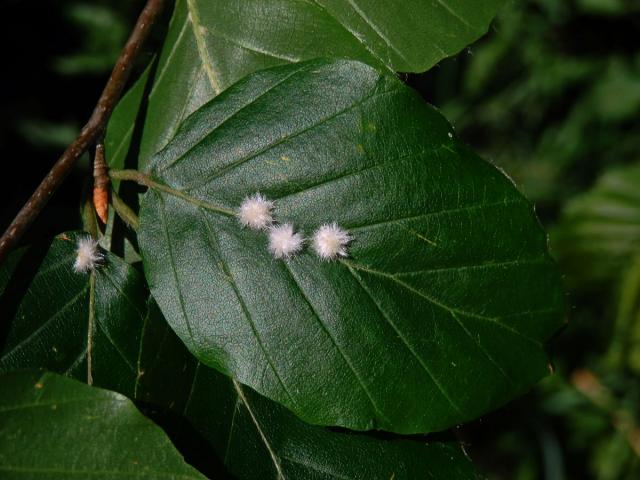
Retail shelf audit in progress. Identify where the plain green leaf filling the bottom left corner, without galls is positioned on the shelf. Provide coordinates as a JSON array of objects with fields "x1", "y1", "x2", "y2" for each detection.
[{"x1": 0, "y1": 372, "x2": 205, "y2": 480}]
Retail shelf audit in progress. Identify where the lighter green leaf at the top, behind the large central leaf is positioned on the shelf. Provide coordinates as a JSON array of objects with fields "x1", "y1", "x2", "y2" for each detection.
[{"x1": 132, "y1": 0, "x2": 503, "y2": 165}]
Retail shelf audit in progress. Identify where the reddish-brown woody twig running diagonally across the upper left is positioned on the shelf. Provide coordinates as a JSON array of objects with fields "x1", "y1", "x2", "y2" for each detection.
[{"x1": 0, "y1": 0, "x2": 164, "y2": 263}]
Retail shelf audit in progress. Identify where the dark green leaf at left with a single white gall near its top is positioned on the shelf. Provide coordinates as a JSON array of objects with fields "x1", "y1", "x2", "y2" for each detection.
[{"x1": 0, "y1": 233, "x2": 148, "y2": 397}]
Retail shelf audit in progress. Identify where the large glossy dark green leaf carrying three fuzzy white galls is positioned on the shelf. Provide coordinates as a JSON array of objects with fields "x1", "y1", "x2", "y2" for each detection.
[{"x1": 138, "y1": 61, "x2": 564, "y2": 433}]
